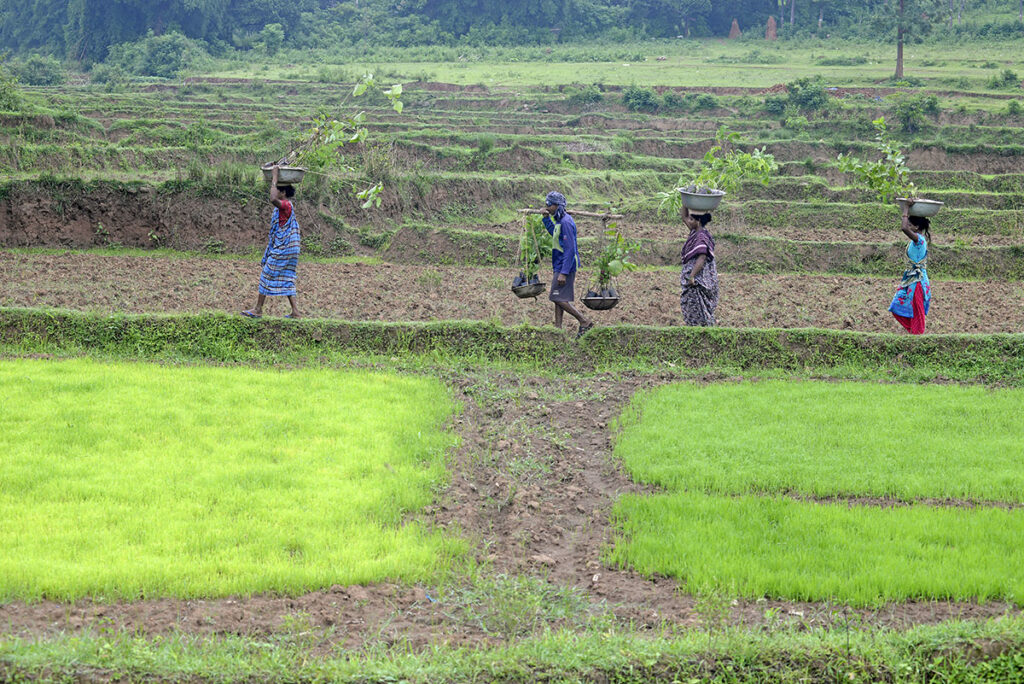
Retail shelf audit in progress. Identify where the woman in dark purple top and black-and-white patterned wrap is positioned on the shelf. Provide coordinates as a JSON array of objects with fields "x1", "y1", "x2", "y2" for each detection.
[{"x1": 679, "y1": 207, "x2": 718, "y2": 326}]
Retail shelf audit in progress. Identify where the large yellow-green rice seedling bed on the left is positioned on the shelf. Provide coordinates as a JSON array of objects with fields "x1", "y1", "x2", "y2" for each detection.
[{"x1": 0, "y1": 360, "x2": 462, "y2": 601}]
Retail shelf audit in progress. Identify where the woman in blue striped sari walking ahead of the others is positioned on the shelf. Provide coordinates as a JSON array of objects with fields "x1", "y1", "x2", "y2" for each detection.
[{"x1": 242, "y1": 166, "x2": 300, "y2": 318}]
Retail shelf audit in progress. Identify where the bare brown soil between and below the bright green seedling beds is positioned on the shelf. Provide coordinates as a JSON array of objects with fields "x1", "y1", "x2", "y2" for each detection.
[{"x1": 0, "y1": 374, "x2": 1016, "y2": 648}]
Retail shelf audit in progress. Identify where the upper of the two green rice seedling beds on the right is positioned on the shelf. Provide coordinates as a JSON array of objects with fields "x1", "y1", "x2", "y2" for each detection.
[{"x1": 615, "y1": 381, "x2": 1024, "y2": 503}]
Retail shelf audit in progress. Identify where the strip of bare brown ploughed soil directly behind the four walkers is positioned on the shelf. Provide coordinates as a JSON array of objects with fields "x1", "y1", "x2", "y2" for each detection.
[{"x1": 0, "y1": 251, "x2": 1024, "y2": 333}]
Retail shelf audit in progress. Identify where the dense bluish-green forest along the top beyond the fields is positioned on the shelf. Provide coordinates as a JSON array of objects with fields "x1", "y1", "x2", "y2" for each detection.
[{"x1": 0, "y1": 0, "x2": 1024, "y2": 63}]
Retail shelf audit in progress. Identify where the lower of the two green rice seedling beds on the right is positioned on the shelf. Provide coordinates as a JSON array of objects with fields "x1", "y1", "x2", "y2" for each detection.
[{"x1": 608, "y1": 491, "x2": 1024, "y2": 606}]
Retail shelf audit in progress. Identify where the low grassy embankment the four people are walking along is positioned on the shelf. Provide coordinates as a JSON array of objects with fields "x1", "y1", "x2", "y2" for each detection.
[{"x1": 0, "y1": 308, "x2": 1024, "y2": 386}]
